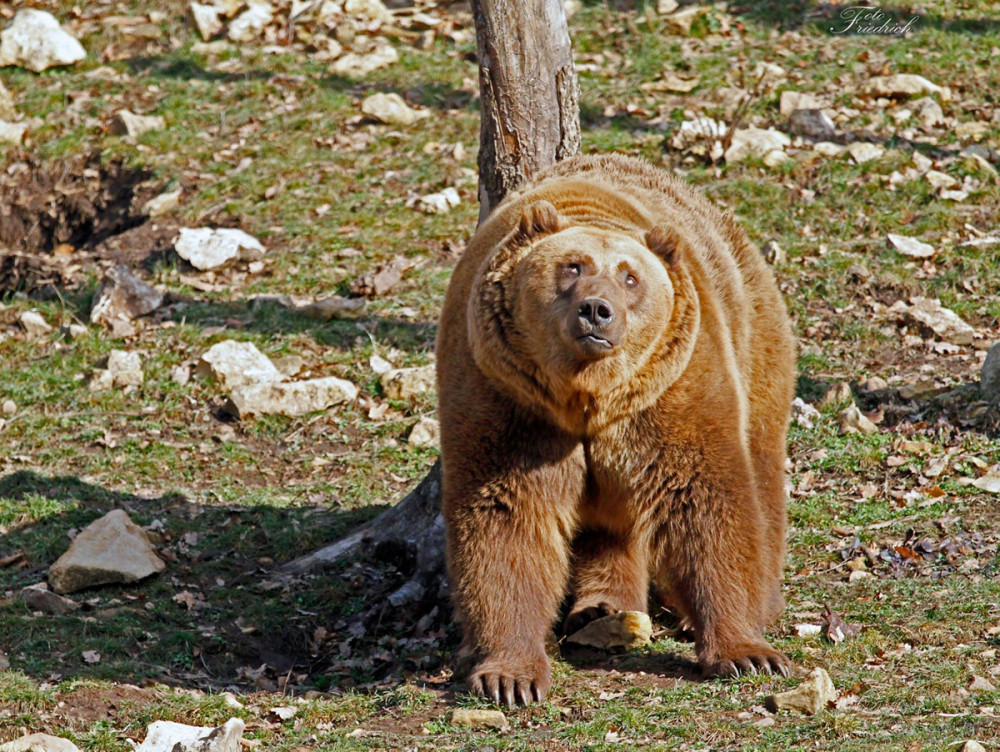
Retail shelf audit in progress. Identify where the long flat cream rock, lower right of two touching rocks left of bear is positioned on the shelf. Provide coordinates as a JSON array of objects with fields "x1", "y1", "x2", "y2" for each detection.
[{"x1": 226, "y1": 376, "x2": 358, "y2": 418}]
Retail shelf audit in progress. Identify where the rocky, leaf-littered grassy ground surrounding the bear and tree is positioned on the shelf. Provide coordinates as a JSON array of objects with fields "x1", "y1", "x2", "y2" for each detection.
[{"x1": 0, "y1": 0, "x2": 1000, "y2": 752}]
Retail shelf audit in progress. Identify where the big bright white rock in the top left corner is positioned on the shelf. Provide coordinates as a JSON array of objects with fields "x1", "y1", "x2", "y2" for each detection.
[{"x1": 0, "y1": 8, "x2": 87, "y2": 73}]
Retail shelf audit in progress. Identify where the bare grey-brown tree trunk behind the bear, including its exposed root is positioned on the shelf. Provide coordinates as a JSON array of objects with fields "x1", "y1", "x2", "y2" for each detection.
[{"x1": 282, "y1": 0, "x2": 580, "y2": 608}]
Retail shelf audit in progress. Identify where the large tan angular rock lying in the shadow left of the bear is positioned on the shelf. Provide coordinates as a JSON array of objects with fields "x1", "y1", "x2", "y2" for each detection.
[{"x1": 49, "y1": 509, "x2": 166, "y2": 594}]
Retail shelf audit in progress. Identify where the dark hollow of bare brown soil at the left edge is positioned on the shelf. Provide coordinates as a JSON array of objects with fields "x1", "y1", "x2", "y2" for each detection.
[{"x1": 0, "y1": 152, "x2": 164, "y2": 293}]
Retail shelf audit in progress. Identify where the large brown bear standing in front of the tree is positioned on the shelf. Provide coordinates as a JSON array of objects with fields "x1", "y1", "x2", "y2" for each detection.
[{"x1": 437, "y1": 155, "x2": 794, "y2": 705}]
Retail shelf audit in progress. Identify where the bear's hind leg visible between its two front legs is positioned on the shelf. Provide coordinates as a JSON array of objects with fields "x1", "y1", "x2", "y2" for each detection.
[{"x1": 563, "y1": 529, "x2": 649, "y2": 635}]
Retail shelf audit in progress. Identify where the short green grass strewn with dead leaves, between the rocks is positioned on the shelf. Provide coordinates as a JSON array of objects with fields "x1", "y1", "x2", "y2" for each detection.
[{"x1": 0, "y1": 0, "x2": 1000, "y2": 752}]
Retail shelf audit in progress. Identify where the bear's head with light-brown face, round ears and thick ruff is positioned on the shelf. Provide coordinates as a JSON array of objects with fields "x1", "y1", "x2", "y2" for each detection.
[{"x1": 470, "y1": 201, "x2": 697, "y2": 434}]
